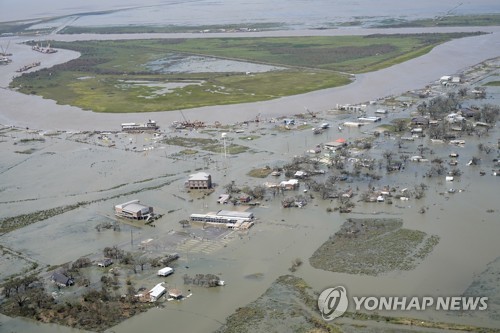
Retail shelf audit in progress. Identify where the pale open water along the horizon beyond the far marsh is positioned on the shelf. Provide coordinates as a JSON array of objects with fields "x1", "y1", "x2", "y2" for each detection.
[{"x1": 0, "y1": 0, "x2": 499, "y2": 29}]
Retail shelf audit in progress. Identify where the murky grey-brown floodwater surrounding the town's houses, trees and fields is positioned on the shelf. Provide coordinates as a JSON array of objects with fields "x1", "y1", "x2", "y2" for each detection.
[{"x1": 0, "y1": 85, "x2": 500, "y2": 333}]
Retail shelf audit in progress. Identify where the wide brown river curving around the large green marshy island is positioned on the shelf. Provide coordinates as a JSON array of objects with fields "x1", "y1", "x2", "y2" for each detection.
[{"x1": 0, "y1": 27, "x2": 500, "y2": 131}]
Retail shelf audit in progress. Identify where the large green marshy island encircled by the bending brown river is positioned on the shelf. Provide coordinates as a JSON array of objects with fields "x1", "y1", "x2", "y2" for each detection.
[{"x1": 11, "y1": 33, "x2": 480, "y2": 113}]
